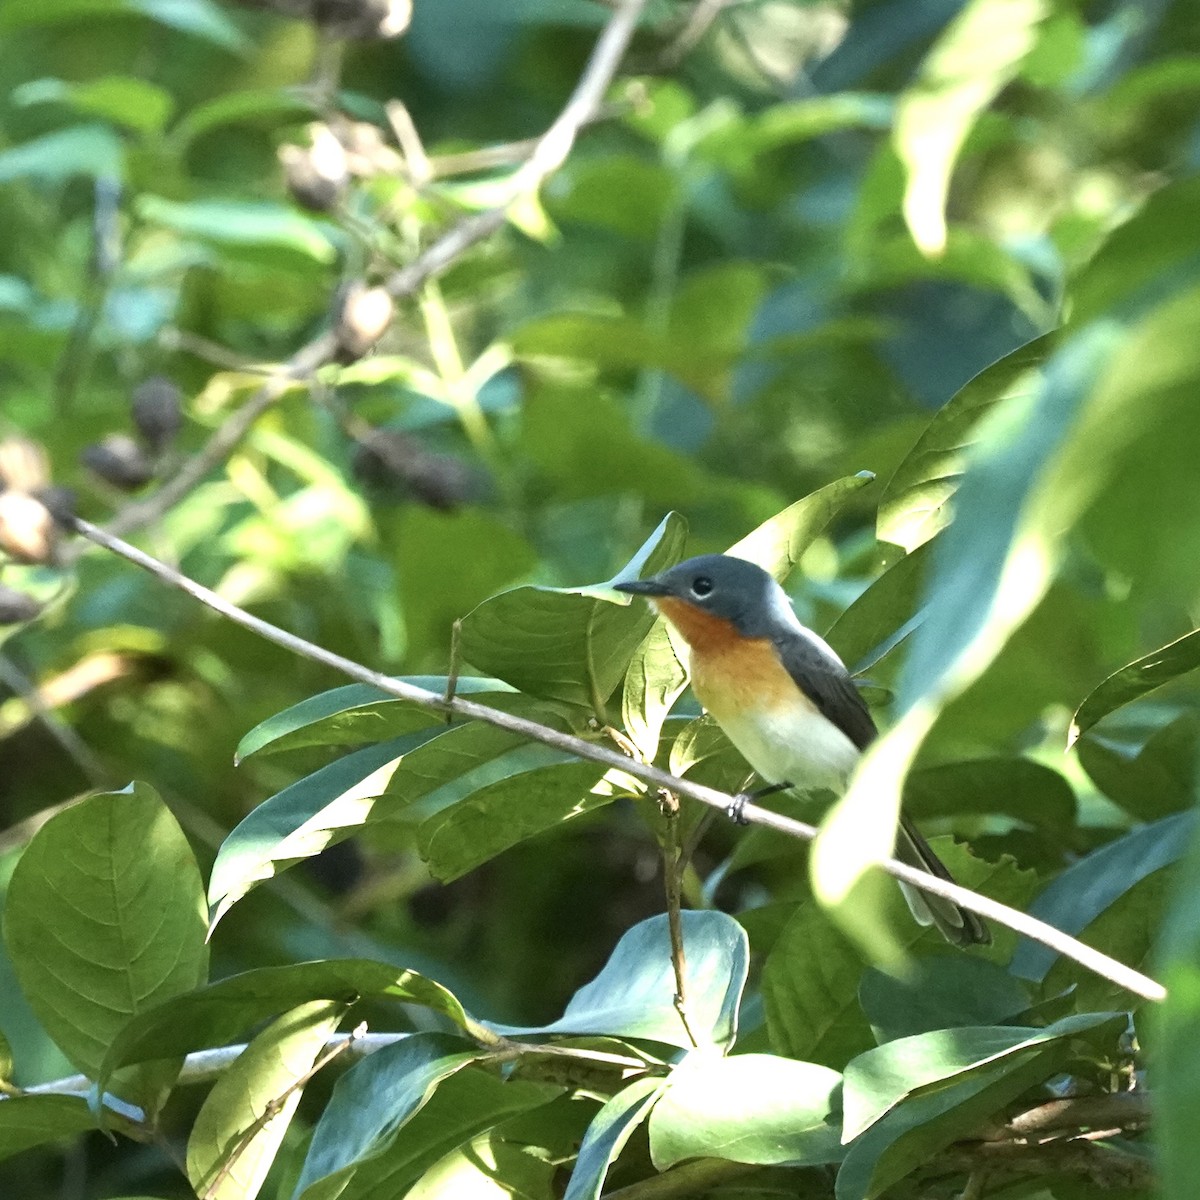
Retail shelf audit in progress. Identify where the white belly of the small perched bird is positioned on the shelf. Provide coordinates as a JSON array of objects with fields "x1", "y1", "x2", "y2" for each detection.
[{"x1": 713, "y1": 706, "x2": 858, "y2": 792}]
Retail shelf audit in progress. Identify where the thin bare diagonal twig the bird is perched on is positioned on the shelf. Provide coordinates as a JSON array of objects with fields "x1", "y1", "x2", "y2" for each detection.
[{"x1": 66, "y1": 517, "x2": 1166, "y2": 1001}]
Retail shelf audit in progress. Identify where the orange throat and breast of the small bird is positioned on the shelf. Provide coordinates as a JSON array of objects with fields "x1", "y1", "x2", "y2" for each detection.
[{"x1": 656, "y1": 596, "x2": 814, "y2": 722}]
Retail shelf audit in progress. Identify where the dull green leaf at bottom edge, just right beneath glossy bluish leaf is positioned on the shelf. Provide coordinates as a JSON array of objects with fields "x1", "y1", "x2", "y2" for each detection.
[{"x1": 326, "y1": 1067, "x2": 563, "y2": 1200}]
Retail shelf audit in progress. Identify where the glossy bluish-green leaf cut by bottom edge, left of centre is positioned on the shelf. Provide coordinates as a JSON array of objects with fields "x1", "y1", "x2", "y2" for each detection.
[{"x1": 292, "y1": 1033, "x2": 484, "y2": 1200}]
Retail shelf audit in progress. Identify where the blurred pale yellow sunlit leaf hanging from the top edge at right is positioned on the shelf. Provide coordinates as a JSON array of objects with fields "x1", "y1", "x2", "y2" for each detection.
[{"x1": 893, "y1": 0, "x2": 1050, "y2": 254}]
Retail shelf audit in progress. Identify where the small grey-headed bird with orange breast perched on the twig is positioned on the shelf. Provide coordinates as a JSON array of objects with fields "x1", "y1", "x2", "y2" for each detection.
[{"x1": 616, "y1": 554, "x2": 991, "y2": 946}]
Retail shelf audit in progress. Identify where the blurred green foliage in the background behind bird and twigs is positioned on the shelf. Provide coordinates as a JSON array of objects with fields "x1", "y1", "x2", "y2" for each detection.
[{"x1": 0, "y1": 0, "x2": 1200, "y2": 1196}]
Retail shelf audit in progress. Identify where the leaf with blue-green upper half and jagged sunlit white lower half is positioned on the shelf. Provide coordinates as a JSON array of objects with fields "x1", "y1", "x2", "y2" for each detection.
[{"x1": 209, "y1": 726, "x2": 444, "y2": 931}]
